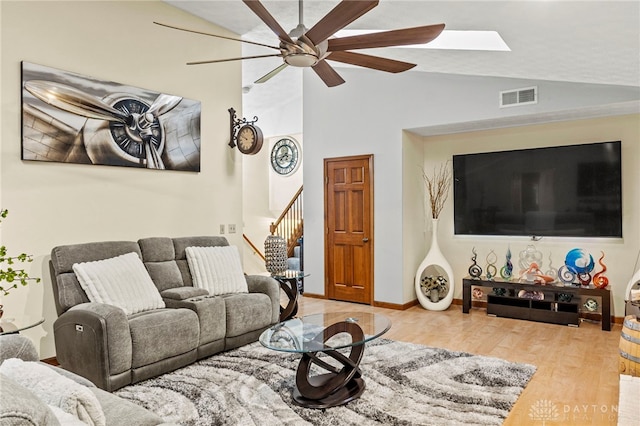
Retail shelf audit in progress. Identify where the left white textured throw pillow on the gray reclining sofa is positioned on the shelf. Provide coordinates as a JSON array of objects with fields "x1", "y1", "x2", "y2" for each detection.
[{"x1": 73, "y1": 252, "x2": 165, "y2": 315}]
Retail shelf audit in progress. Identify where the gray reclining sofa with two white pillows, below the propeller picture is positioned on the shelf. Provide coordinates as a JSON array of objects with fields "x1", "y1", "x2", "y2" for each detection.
[{"x1": 50, "y1": 236, "x2": 280, "y2": 391}]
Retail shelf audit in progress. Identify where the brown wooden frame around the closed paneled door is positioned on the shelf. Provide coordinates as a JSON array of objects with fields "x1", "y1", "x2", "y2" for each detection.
[{"x1": 322, "y1": 154, "x2": 375, "y2": 306}]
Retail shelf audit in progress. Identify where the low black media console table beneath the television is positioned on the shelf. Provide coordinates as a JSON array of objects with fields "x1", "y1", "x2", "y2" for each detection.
[{"x1": 462, "y1": 278, "x2": 611, "y2": 331}]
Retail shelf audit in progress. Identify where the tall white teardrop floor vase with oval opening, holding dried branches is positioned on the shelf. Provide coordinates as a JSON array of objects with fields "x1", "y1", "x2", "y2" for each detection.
[{"x1": 415, "y1": 219, "x2": 455, "y2": 311}]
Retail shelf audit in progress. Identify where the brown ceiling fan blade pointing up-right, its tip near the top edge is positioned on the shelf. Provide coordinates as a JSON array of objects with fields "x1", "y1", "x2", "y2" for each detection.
[{"x1": 305, "y1": 0, "x2": 378, "y2": 45}]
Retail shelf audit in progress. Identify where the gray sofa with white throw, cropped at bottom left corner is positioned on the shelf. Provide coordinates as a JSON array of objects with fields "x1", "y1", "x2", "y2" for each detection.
[{"x1": 0, "y1": 334, "x2": 169, "y2": 426}]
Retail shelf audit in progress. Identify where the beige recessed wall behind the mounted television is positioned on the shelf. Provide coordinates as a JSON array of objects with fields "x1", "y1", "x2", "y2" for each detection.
[{"x1": 404, "y1": 114, "x2": 640, "y2": 317}]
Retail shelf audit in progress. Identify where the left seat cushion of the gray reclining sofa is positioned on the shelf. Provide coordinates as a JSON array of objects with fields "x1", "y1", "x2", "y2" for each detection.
[{"x1": 129, "y1": 309, "x2": 200, "y2": 368}]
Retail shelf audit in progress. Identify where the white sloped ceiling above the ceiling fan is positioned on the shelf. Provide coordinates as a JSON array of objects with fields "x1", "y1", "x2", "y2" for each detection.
[{"x1": 165, "y1": 0, "x2": 640, "y2": 87}]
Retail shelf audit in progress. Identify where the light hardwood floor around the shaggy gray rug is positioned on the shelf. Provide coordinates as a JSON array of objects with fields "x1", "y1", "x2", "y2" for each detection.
[{"x1": 298, "y1": 296, "x2": 624, "y2": 426}]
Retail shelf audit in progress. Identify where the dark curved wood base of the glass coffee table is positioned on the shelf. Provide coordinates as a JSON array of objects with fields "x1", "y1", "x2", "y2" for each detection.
[{"x1": 293, "y1": 321, "x2": 365, "y2": 408}]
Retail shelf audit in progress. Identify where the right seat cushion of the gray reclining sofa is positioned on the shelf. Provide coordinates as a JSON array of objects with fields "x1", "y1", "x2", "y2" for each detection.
[{"x1": 223, "y1": 293, "x2": 272, "y2": 337}]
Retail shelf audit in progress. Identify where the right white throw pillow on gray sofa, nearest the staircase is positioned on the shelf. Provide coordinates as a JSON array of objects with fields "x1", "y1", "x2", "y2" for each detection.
[{"x1": 185, "y1": 246, "x2": 249, "y2": 296}]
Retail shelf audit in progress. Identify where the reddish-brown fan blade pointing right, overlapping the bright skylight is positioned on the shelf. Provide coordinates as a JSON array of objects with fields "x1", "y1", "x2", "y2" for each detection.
[{"x1": 327, "y1": 24, "x2": 444, "y2": 52}]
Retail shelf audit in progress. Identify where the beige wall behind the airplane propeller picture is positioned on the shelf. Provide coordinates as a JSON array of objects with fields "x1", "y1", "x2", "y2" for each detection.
[{"x1": 0, "y1": 1, "x2": 242, "y2": 358}]
